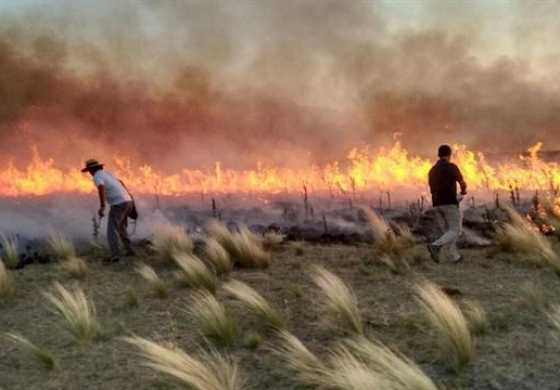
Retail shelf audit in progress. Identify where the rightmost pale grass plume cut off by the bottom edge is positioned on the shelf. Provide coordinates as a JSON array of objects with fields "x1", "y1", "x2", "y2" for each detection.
[{"x1": 346, "y1": 337, "x2": 437, "y2": 390}]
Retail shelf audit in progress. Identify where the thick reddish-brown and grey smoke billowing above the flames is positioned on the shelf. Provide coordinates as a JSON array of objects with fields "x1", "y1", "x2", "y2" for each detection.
[{"x1": 0, "y1": 0, "x2": 560, "y2": 171}]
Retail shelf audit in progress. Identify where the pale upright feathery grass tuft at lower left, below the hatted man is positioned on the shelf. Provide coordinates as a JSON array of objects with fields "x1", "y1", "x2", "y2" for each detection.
[{"x1": 43, "y1": 282, "x2": 101, "y2": 342}]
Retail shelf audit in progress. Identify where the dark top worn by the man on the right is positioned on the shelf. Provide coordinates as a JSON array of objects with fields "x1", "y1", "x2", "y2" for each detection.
[{"x1": 429, "y1": 160, "x2": 467, "y2": 207}]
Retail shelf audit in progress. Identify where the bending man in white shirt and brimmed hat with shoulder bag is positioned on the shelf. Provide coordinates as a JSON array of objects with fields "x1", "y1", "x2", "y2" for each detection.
[{"x1": 82, "y1": 159, "x2": 134, "y2": 263}]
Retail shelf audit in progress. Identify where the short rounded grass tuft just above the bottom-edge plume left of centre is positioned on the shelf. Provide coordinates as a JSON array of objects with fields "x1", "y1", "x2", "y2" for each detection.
[{"x1": 189, "y1": 291, "x2": 237, "y2": 346}]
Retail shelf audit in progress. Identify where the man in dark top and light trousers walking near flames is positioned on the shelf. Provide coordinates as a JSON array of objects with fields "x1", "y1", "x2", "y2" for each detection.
[{"x1": 428, "y1": 145, "x2": 467, "y2": 263}]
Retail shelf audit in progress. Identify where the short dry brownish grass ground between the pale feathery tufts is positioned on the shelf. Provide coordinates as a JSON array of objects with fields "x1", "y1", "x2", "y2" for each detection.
[{"x1": 0, "y1": 243, "x2": 560, "y2": 390}]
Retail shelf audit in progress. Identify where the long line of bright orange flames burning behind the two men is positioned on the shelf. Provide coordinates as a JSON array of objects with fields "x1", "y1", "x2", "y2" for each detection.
[{"x1": 0, "y1": 142, "x2": 560, "y2": 197}]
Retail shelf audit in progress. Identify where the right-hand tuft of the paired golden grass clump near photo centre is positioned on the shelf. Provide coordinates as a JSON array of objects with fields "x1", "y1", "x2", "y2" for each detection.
[{"x1": 233, "y1": 226, "x2": 270, "y2": 268}]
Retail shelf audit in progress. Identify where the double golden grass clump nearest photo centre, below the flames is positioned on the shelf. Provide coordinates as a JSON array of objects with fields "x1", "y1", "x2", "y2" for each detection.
[{"x1": 206, "y1": 221, "x2": 270, "y2": 268}]
